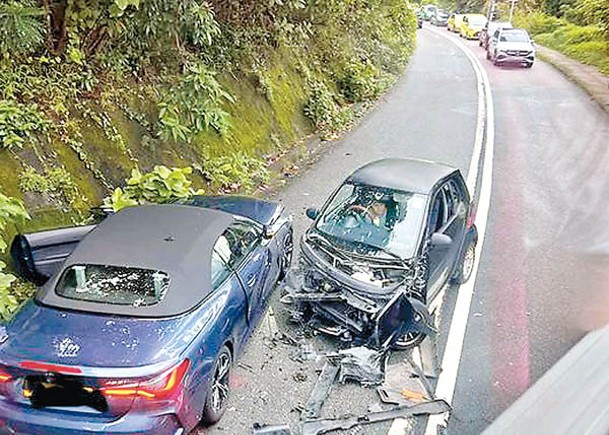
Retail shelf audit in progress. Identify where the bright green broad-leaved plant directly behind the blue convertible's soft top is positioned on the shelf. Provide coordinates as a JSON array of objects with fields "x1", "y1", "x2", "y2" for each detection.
[{"x1": 104, "y1": 166, "x2": 203, "y2": 212}]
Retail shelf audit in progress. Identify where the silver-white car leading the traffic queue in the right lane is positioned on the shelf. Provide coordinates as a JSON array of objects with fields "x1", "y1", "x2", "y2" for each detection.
[{"x1": 486, "y1": 29, "x2": 535, "y2": 68}]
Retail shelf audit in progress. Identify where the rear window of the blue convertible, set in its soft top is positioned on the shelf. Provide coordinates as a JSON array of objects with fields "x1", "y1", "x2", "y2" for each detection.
[{"x1": 55, "y1": 264, "x2": 169, "y2": 307}]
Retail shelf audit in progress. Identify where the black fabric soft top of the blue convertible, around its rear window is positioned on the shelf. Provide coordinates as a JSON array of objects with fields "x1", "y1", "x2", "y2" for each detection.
[{"x1": 37, "y1": 204, "x2": 235, "y2": 317}]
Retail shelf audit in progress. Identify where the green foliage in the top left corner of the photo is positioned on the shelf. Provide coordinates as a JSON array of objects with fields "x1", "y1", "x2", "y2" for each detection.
[{"x1": 0, "y1": 0, "x2": 44, "y2": 54}]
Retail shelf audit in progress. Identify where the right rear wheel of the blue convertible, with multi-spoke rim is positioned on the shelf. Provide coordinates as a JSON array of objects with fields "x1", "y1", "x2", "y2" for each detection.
[{"x1": 201, "y1": 346, "x2": 233, "y2": 426}]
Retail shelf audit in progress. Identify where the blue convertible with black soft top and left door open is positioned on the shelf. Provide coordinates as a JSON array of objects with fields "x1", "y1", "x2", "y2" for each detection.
[{"x1": 0, "y1": 196, "x2": 292, "y2": 435}]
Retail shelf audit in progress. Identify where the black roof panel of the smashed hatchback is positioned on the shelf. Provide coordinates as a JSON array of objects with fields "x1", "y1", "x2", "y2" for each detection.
[{"x1": 346, "y1": 158, "x2": 459, "y2": 195}]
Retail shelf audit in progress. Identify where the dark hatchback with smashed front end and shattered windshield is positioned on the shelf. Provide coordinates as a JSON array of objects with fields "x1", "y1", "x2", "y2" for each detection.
[{"x1": 282, "y1": 159, "x2": 477, "y2": 349}]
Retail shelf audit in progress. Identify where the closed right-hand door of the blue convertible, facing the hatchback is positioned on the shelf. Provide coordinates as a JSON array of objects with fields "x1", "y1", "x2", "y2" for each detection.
[{"x1": 226, "y1": 222, "x2": 274, "y2": 326}]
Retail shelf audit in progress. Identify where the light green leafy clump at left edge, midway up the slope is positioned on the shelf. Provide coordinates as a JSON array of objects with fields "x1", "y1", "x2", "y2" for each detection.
[{"x1": 0, "y1": 100, "x2": 50, "y2": 149}]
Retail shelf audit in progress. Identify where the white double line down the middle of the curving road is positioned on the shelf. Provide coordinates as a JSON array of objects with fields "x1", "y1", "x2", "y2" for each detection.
[{"x1": 425, "y1": 26, "x2": 495, "y2": 435}]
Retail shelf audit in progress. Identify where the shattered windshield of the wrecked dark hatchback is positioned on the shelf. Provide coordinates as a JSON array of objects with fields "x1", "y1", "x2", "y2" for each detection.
[{"x1": 315, "y1": 184, "x2": 427, "y2": 259}]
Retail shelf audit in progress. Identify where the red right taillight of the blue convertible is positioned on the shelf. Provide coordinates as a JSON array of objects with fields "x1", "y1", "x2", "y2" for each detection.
[{"x1": 100, "y1": 359, "x2": 190, "y2": 399}]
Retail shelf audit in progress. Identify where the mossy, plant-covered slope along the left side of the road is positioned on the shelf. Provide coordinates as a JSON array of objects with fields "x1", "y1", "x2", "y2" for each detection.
[{"x1": 0, "y1": 0, "x2": 416, "y2": 316}]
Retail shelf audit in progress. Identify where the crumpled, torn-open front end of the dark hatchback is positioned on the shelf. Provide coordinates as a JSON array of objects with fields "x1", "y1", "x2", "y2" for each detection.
[{"x1": 282, "y1": 233, "x2": 432, "y2": 348}]
